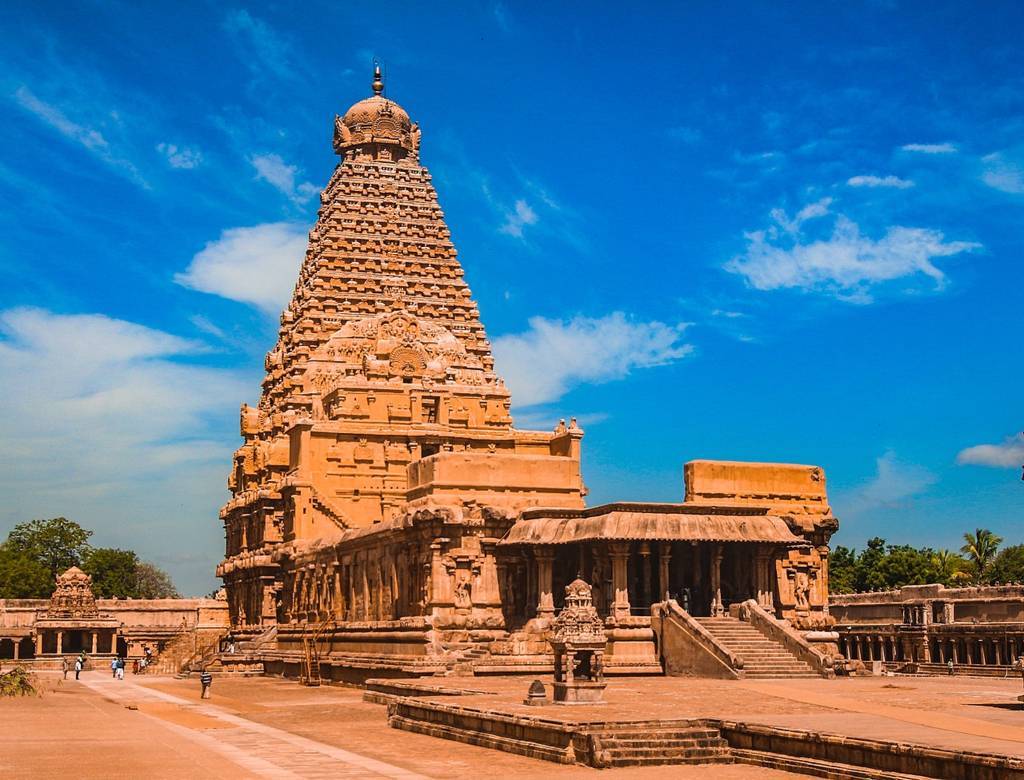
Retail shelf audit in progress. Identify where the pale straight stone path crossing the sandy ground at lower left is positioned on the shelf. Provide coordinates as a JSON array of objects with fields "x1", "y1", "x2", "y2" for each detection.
[{"x1": 83, "y1": 676, "x2": 426, "y2": 780}]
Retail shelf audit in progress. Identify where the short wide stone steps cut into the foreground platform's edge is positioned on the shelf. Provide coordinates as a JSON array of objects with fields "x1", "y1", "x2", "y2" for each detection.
[{"x1": 591, "y1": 726, "x2": 732, "y2": 767}]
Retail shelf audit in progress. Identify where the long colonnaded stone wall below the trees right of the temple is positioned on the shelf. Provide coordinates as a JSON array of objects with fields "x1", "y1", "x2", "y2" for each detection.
[{"x1": 831, "y1": 584, "x2": 1024, "y2": 671}]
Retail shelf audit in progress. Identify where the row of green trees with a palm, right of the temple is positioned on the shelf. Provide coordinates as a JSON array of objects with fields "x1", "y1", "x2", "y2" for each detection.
[{"x1": 828, "y1": 528, "x2": 1024, "y2": 593}]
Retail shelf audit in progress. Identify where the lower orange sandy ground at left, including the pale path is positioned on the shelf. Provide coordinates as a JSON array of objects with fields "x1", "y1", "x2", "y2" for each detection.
[{"x1": 0, "y1": 671, "x2": 796, "y2": 780}]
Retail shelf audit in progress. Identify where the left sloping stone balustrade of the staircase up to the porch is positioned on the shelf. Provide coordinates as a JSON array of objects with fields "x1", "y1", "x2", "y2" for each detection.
[{"x1": 650, "y1": 599, "x2": 743, "y2": 679}]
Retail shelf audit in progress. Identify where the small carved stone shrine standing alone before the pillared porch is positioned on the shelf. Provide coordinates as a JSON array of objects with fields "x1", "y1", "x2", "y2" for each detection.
[{"x1": 551, "y1": 578, "x2": 607, "y2": 704}]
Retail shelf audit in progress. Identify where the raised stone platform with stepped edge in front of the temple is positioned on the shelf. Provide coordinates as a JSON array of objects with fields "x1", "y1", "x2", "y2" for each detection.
[{"x1": 366, "y1": 678, "x2": 1024, "y2": 780}]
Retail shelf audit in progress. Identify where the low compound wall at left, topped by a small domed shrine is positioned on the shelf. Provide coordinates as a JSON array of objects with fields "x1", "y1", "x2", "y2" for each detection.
[{"x1": 0, "y1": 567, "x2": 228, "y2": 662}]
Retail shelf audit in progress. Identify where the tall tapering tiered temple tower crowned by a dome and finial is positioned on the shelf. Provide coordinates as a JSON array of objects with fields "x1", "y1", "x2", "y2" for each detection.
[{"x1": 218, "y1": 69, "x2": 582, "y2": 627}]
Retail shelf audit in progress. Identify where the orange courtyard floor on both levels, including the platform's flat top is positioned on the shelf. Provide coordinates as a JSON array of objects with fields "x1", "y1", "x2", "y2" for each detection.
[{"x1": 6, "y1": 671, "x2": 1024, "y2": 780}]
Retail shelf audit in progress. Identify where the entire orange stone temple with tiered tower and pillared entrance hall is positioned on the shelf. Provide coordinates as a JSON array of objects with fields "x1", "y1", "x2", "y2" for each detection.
[{"x1": 217, "y1": 72, "x2": 838, "y2": 679}]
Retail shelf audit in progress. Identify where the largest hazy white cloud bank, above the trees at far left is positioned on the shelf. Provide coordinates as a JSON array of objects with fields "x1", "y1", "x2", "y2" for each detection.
[{"x1": 0, "y1": 308, "x2": 246, "y2": 593}]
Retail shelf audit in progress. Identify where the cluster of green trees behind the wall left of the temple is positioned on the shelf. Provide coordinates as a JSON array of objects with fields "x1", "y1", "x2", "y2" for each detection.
[{"x1": 0, "y1": 517, "x2": 178, "y2": 599}]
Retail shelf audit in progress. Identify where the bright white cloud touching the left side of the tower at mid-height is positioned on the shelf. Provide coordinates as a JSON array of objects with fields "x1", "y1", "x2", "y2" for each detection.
[{"x1": 174, "y1": 222, "x2": 307, "y2": 313}]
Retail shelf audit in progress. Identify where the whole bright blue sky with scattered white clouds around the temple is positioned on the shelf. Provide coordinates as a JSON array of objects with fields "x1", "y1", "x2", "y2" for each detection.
[{"x1": 0, "y1": 2, "x2": 1024, "y2": 593}]
